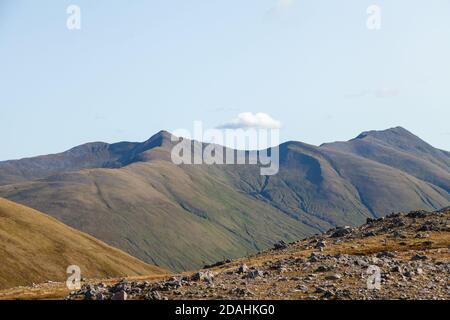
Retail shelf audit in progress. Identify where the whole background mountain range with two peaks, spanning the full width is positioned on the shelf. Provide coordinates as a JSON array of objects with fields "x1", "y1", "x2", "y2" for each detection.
[{"x1": 0, "y1": 128, "x2": 450, "y2": 271}]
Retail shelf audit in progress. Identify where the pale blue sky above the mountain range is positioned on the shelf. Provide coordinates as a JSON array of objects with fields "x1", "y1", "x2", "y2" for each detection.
[{"x1": 0, "y1": 0, "x2": 450, "y2": 160}]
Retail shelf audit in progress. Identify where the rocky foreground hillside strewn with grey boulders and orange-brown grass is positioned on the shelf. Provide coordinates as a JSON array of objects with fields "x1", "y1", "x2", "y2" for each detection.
[{"x1": 67, "y1": 208, "x2": 450, "y2": 300}]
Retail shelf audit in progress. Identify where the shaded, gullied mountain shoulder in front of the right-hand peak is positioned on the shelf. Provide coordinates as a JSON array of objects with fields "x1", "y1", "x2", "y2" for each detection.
[{"x1": 225, "y1": 142, "x2": 450, "y2": 225}]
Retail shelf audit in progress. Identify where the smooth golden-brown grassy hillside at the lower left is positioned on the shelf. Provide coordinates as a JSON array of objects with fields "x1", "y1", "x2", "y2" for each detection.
[{"x1": 0, "y1": 199, "x2": 166, "y2": 289}]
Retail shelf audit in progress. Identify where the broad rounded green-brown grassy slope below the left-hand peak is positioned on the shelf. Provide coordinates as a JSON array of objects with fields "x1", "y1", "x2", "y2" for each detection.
[{"x1": 1, "y1": 160, "x2": 316, "y2": 270}]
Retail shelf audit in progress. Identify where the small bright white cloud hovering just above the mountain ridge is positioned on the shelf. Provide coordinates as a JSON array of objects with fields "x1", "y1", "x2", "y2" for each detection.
[{"x1": 218, "y1": 112, "x2": 281, "y2": 129}]
